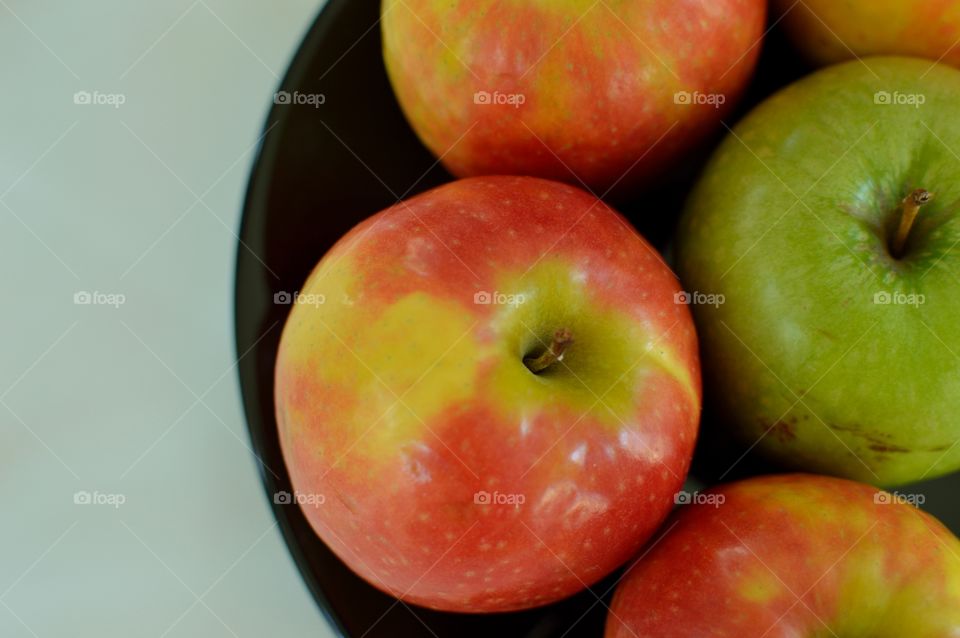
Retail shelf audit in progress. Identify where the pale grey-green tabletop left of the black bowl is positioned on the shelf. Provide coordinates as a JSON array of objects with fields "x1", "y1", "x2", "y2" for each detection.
[{"x1": 0, "y1": 0, "x2": 338, "y2": 638}]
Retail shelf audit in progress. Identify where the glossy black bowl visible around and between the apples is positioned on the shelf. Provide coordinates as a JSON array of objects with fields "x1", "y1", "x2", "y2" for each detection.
[{"x1": 236, "y1": 0, "x2": 960, "y2": 638}]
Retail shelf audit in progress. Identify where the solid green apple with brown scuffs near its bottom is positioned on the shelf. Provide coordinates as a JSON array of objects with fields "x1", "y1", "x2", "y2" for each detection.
[{"x1": 677, "y1": 57, "x2": 960, "y2": 485}]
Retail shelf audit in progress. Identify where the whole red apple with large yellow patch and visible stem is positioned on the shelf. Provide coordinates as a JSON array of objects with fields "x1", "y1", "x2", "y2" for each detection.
[{"x1": 276, "y1": 177, "x2": 700, "y2": 612}]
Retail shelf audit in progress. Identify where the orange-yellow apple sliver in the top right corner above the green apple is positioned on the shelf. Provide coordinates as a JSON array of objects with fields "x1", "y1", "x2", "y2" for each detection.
[{"x1": 771, "y1": 0, "x2": 960, "y2": 66}]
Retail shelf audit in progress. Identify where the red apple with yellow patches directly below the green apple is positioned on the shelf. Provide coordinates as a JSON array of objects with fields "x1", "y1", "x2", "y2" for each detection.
[{"x1": 605, "y1": 474, "x2": 960, "y2": 638}]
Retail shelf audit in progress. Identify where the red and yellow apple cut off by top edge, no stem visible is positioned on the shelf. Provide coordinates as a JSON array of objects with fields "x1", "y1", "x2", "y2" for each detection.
[{"x1": 382, "y1": 0, "x2": 766, "y2": 195}]
